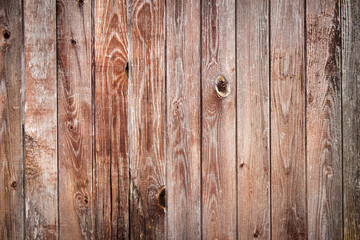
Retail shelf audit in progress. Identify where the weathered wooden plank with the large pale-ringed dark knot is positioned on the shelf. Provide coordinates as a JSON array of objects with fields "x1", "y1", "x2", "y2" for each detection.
[{"x1": 201, "y1": 0, "x2": 237, "y2": 239}]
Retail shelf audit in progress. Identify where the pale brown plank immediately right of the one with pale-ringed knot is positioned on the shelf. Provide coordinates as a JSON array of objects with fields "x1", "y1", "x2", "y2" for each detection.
[{"x1": 236, "y1": 0, "x2": 270, "y2": 239}]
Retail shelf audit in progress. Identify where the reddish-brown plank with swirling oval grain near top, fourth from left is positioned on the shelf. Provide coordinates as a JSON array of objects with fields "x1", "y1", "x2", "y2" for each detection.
[{"x1": 94, "y1": 0, "x2": 129, "y2": 239}]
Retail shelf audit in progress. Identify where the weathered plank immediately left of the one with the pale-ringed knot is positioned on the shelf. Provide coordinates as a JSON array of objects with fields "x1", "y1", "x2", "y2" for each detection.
[{"x1": 166, "y1": 0, "x2": 201, "y2": 239}]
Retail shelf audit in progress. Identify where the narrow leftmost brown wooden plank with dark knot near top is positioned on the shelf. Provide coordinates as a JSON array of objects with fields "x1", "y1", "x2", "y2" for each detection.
[{"x1": 0, "y1": 0, "x2": 24, "y2": 239}]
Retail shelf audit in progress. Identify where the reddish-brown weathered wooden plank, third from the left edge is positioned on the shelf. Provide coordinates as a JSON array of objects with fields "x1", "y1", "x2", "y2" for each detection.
[{"x1": 56, "y1": 0, "x2": 93, "y2": 239}]
